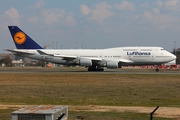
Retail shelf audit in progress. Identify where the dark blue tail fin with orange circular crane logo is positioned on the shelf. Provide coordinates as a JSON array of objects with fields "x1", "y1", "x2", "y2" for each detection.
[{"x1": 8, "y1": 26, "x2": 43, "y2": 49}]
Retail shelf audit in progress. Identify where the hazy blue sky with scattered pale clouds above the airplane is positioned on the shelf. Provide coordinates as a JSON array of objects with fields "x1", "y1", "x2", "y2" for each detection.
[{"x1": 0, "y1": 0, "x2": 180, "y2": 53}]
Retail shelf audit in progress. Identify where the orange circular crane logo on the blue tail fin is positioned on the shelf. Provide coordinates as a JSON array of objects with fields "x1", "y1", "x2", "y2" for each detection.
[{"x1": 14, "y1": 32, "x2": 26, "y2": 44}]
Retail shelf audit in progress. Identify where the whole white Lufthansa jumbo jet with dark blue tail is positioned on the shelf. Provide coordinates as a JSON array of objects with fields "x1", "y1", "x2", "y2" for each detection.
[{"x1": 6, "y1": 26, "x2": 176, "y2": 71}]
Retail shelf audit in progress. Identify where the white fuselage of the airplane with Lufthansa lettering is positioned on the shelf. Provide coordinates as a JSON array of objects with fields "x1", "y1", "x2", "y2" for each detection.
[{"x1": 14, "y1": 47, "x2": 176, "y2": 66}]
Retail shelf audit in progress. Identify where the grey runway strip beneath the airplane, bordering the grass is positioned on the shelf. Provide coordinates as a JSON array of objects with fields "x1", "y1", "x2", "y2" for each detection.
[{"x1": 0, "y1": 67, "x2": 180, "y2": 74}]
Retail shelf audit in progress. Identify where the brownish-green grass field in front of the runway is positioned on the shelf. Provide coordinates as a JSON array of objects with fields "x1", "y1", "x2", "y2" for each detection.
[{"x1": 0, "y1": 67, "x2": 180, "y2": 120}]
